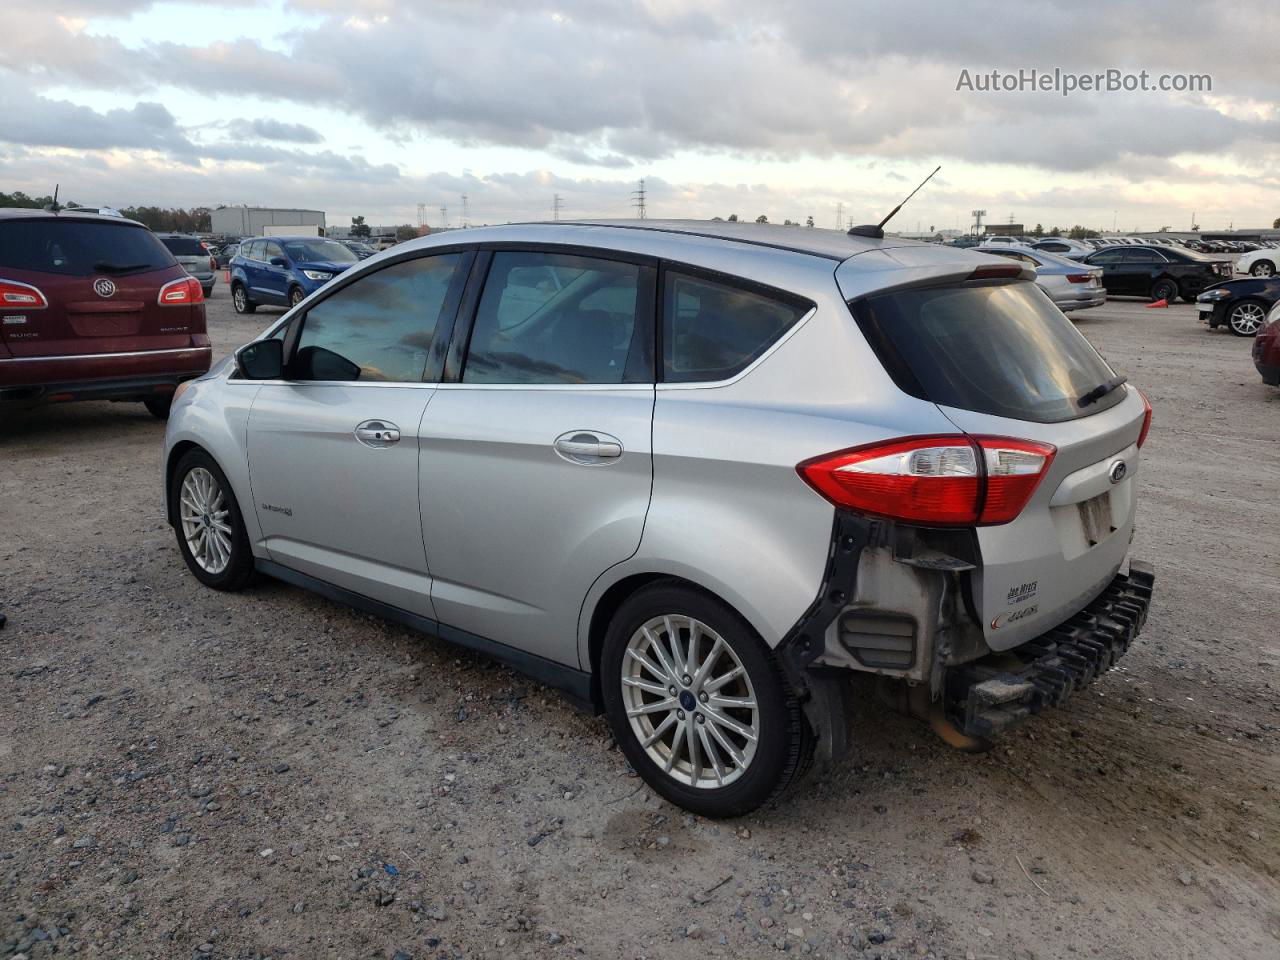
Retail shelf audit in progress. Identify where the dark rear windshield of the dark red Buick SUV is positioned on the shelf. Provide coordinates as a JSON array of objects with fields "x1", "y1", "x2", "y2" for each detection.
[{"x1": 0, "y1": 218, "x2": 174, "y2": 276}]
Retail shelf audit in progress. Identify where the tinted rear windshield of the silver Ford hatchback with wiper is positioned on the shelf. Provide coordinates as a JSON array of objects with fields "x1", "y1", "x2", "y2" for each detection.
[{"x1": 850, "y1": 283, "x2": 1124, "y2": 424}]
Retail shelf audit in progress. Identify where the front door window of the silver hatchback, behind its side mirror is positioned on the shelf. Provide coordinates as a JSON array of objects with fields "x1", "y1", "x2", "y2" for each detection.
[{"x1": 289, "y1": 253, "x2": 465, "y2": 383}]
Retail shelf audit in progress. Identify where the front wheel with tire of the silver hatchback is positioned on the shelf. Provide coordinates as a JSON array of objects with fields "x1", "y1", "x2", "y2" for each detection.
[{"x1": 169, "y1": 449, "x2": 253, "y2": 590}]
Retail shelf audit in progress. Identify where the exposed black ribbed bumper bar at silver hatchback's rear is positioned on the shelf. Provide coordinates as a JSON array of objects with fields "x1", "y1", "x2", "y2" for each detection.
[{"x1": 943, "y1": 561, "x2": 1156, "y2": 739}]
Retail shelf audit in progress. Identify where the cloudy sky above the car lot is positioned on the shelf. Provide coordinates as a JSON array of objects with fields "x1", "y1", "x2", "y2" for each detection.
[{"x1": 0, "y1": 0, "x2": 1280, "y2": 232}]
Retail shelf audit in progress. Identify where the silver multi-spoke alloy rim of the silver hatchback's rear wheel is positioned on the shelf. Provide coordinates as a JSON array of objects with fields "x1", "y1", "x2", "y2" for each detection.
[{"x1": 621, "y1": 614, "x2": 760, "y2": 790}]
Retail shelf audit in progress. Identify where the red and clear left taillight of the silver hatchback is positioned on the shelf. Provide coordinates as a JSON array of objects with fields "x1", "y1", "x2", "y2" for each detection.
[{"x1": 796, "y1": 435, "x2": 1057, "y2": 526}]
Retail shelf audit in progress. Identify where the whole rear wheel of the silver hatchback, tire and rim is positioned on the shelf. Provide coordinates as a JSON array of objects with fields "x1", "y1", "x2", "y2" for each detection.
[{"x1": 600, "y1": 581, "x2": 813, "y2": 817}]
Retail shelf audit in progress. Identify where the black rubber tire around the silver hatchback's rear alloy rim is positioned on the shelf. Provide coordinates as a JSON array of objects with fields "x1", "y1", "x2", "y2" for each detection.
[{"x1": 600, "y1": 580, "x2": 814, "y2": 818}]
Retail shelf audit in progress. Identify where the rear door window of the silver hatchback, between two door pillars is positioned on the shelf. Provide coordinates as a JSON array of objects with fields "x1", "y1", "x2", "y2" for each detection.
[{"x1": 462, "y1": 252, "x2": 653, "y2": 384}]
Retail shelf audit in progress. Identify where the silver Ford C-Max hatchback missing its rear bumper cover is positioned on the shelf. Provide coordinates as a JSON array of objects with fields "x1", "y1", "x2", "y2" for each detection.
[{"x1": 164, "y1": 220, "x2": 1153, "y2": 815}]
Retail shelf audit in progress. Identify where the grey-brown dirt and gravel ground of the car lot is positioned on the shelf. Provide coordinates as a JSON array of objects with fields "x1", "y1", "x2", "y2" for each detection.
[{"x1": 0, "y1": 285, "x2": 1280, "y2": 960}]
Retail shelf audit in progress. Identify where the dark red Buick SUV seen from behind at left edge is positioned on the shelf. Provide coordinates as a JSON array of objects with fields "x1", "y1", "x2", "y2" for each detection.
[{"x1": 0, "y1": 210, "x2": 211, "y2": 419}]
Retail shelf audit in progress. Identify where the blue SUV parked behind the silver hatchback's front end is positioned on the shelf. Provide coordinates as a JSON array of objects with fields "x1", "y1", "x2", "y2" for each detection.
[{"x1": 230, "y1": 237, "x2": 360, "y2": 314}]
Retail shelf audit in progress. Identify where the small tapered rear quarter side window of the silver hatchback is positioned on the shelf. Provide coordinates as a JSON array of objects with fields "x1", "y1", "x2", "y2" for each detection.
[{"x1": 662, "y1": 271, "x2": 810, "y2": 383}]
